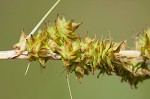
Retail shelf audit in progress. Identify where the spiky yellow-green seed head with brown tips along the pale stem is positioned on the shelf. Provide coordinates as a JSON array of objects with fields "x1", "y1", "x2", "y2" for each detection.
[{"x1": 14, "y1": 17, "x2": 150, "y2": 87}]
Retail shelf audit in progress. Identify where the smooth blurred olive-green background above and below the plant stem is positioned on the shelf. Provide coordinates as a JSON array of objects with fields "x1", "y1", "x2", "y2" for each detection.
[{"x1": 0, "y1": 0, "x2": 150, "y2": 99}]
